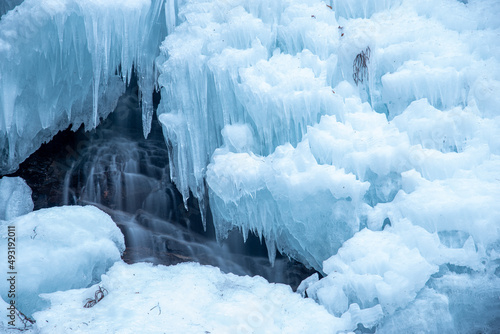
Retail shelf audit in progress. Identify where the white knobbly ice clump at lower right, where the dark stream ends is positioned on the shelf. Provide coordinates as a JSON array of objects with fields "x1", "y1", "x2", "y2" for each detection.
[{"x1": 306, "y1": 229, "x2": 438, "y2": 314}]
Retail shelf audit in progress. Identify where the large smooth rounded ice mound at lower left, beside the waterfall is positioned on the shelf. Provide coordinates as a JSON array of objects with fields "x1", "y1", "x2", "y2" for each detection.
[{"x1": 0, "y1": 206, "x2": 125, "y2": 316}]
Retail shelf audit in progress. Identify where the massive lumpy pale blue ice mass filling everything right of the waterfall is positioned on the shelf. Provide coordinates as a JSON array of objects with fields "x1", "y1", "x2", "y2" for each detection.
[{"x1": 157, "y1": 0, "x2": 500, "y2": 332}]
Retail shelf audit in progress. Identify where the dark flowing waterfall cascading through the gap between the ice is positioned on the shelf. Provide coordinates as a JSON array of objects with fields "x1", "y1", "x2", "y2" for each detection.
[{"x1": 10, "y1": 79, "x2": 311, "y2": 288}]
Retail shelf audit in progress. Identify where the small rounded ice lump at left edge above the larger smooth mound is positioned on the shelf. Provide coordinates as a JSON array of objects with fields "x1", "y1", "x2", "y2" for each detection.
[{"x1": 0, "y1": 176, "x2": 33, "y2": 220}]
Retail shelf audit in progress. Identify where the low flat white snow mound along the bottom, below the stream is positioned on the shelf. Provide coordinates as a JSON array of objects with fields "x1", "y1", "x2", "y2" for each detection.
[{"x1": 34, "y1": 262, "x2": 352, "y2": 334}]
